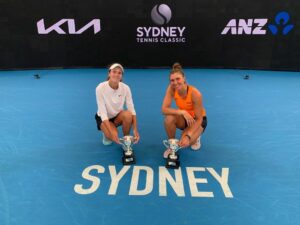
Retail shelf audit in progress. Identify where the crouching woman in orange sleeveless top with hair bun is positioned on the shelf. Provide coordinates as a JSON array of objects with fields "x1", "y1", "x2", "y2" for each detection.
[{"x1": 162, "y1": 63, "x2": 207, "y2": 158}]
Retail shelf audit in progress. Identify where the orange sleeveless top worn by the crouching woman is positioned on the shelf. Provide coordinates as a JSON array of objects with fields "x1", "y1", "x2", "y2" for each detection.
[{"x1": 174, "y1": 85, "x2": 206, "y2": 118}]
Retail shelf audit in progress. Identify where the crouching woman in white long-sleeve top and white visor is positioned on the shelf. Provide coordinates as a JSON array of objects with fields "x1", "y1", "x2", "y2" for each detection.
[{"x1": 95, "y1": 63, "x2": 140, "y2": 145}]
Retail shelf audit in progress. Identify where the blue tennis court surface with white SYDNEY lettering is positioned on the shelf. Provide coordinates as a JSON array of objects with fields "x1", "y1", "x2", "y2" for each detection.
[{"x1": 0, "y1": 69, "x2": 300, "y2": 225}]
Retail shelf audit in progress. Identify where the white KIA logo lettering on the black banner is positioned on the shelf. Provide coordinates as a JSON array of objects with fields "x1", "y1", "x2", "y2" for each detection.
[{"x1": 37, "y1": 19, "x2": 101, "y2": 34}]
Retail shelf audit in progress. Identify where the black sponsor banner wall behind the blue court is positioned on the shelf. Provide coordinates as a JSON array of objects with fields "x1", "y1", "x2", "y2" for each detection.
[{"x1": 0, "y1": 0, "x2": 300, "y2": 71}]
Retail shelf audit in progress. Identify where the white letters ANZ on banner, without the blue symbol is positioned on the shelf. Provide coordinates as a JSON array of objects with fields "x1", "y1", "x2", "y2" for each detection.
[{"x1": 221, "y1": 19, "x2": 268, "y2": 35}]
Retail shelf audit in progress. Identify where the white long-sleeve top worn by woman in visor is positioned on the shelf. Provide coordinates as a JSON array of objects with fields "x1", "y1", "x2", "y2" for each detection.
[{"x1": 96, "y1": 81, "x2": 136, "y2": 121}]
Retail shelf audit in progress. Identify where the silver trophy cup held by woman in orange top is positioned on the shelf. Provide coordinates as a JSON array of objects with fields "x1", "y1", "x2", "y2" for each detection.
[{"x1": 163, "y1": 138, "x2": 181, "y2": 169}]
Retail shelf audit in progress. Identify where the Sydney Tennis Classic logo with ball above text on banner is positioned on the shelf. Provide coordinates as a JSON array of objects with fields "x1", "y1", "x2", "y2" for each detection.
[{"x1": 136, "y1": 4, "x2": 186, "y2": 43}]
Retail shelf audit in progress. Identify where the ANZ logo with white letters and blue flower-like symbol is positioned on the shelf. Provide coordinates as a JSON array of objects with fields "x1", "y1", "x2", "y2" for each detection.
[{"x1": 221, "y1": 12, "x2": 294, "y2": 35}]
